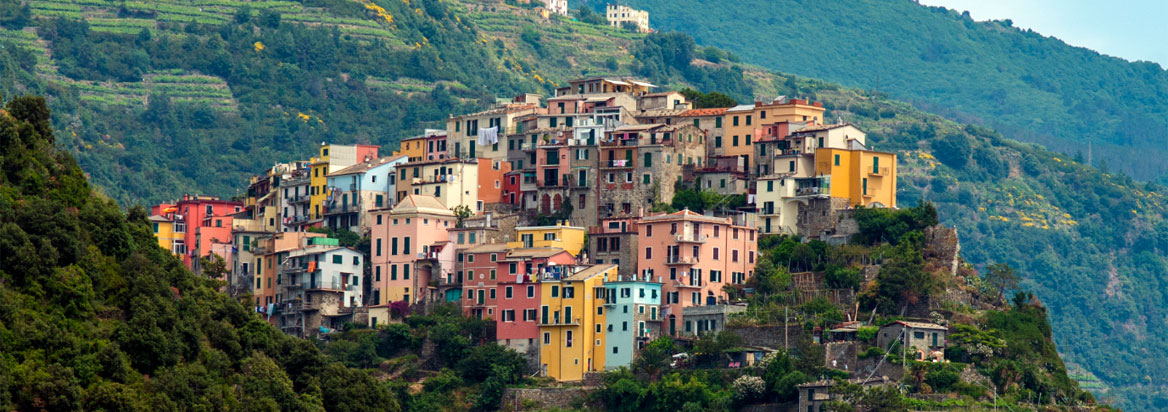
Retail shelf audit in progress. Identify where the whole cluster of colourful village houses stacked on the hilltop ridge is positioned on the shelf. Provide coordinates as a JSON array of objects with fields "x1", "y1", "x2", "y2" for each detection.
[{"x1": 141, "y1": 77, "x2": 1097, "y2": 411}]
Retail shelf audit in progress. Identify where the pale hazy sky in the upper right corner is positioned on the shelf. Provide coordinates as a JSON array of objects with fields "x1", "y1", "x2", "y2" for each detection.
[{"x1": 918, "y1": 0, "x2": 1168, "y2": 68}]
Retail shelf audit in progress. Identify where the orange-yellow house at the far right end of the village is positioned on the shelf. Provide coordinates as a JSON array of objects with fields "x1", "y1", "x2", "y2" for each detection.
[{"x1": 815, "y1": 148, "x2": 896, "y2": 208}]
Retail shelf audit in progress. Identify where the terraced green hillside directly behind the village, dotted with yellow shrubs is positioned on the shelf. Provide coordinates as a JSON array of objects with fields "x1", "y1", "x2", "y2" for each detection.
[{"x1": 0, "y1": 0, "x2": 1168, "y2": 410}]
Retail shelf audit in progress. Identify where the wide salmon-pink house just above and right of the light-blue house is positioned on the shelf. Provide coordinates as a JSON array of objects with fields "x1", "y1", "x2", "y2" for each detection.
[{"x1": 637, "y1": 210, "x2": 758, "y2": 336}]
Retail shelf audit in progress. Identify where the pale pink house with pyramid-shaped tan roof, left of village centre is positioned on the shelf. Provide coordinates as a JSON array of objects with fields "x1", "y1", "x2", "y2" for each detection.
[{"x1": 369, "y1": 195, "x2": 456, "y2": 310}]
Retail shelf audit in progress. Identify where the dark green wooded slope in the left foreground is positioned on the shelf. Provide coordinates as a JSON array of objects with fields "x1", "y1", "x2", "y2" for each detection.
[{"x1": 0, "y1": 97, "x2": 402, "y2": 411}]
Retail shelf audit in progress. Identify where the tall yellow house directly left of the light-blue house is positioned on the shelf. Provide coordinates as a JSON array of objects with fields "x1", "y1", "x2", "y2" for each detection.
[{"x1": 540, "y1": 264, "x2": 618, "y2": 380}]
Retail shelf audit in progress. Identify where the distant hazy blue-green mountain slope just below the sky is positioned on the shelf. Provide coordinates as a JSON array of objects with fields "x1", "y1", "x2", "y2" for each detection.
[{"x1": 621, "y1": 0, "x2": 1168, "y2": 182}]
